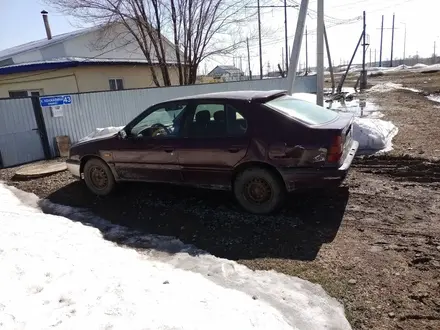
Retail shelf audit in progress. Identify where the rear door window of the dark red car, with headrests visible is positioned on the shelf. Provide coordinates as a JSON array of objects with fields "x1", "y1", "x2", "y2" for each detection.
[{"x1": 188, "y1": 103, "x2": 227, "y2": 138}]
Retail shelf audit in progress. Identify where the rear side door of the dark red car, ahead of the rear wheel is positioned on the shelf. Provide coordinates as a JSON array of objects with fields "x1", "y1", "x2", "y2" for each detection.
[{"x1": 178, "y1": 100, "x2": 250, "y2": 189}]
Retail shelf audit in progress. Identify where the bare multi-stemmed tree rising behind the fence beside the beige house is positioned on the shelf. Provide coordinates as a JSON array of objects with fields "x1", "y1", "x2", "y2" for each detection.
[{"x1": 46, "y1": 0, "x2": 255, "y2": 86}]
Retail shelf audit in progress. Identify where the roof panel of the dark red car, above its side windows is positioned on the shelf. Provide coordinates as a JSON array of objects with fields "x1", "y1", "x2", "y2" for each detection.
[{"x1": 168, "y1": 90, "x2": 287, "y2": 102}]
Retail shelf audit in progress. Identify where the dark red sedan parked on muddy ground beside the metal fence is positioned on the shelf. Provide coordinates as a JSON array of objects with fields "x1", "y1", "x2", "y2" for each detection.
[{"x1": 67, "y1": 91, "x2": 359, "y2": 214}]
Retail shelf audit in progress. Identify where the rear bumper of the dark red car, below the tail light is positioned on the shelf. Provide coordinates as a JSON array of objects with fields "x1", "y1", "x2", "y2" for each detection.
[{"x1": 280, "y1": 141, "x2": 359, "y2": 191}]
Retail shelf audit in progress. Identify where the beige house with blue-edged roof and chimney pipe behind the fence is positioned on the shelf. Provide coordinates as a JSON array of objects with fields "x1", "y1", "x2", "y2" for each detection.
[{"x1": 0, "y1": 12, "x2": 179, "y2": 98}]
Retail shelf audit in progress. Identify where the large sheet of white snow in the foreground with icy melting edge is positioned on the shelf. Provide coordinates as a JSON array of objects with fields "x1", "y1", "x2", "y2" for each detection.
[{"x1": 0, "y1": 183, "x2": 350, "y2": 330}]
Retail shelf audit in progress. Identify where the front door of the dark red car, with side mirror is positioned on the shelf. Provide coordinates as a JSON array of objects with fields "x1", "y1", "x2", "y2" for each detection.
[{"x1": 112, "y1": 103, "x2": 186, "y2": 183}]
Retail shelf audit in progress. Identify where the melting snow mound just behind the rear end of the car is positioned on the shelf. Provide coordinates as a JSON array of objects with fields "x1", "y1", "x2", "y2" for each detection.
[{"x1": 353, "y1": 117, "x2": 398, "y2": 152}]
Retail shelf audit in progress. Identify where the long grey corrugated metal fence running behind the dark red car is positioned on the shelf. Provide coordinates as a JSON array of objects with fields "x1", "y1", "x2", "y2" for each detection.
[{"x1": 42, "y1": 76, "x2": 316, "y2": 156}]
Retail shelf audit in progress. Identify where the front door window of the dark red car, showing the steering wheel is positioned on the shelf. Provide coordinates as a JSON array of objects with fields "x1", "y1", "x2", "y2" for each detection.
[{"x1": 130, "y1": 104, "x2": 186, "y2": 138}]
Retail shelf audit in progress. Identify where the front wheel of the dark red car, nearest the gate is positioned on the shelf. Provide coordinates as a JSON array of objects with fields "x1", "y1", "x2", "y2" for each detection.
[{"x1": 84, "y1": 158, "x2": 116, "y2": 196}]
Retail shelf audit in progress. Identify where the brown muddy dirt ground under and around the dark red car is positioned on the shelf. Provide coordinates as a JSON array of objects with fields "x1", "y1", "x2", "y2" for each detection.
[{"x1": 0, "y1": 74, "x2": 440, "y2": 330}]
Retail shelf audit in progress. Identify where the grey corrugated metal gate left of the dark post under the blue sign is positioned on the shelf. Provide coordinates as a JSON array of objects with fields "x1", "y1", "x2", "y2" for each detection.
[{"x1": 0, "y1": 98, "x2": 45, "y2": 168}]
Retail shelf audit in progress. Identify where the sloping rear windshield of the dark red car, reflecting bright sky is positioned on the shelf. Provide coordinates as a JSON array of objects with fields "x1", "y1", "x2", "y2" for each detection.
[{"x1": 265, "y1": 95, "x2": 338, "y2": 125}]
